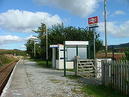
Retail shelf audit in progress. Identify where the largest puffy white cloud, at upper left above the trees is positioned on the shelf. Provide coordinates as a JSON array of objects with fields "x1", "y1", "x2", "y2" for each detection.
[{"x1": 0, "y1": 10, "x2": 62, "y2": 32}]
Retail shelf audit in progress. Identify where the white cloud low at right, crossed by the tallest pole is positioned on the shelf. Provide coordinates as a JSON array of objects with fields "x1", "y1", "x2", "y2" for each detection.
[{"x1": 99, "y1": 20, "x2": 129, "y2": 37}]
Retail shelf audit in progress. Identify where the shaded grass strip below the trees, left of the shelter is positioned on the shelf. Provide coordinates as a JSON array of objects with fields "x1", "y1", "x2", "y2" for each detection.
[{"x1": 30, "y1": 59, "x2": 52, "y2": 68}]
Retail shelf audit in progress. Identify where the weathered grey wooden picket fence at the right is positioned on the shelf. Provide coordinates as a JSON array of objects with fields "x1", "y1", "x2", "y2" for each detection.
[{"x1": 102, "y1": 61, "x2": 129, "y2": 95}]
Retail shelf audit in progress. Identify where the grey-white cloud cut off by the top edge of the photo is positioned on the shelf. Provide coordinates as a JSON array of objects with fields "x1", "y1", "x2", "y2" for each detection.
[{"x1": 35, "y1": 0, "x2": 101, "y2": 17}]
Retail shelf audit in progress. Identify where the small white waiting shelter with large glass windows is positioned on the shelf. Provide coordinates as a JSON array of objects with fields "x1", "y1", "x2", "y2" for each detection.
[{"x1": 50, "y1": 41, "x2": 89, "y2": 69}]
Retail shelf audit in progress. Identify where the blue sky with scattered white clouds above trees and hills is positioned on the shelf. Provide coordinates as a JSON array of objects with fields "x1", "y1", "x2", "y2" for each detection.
[{"x1": 0, "y1": 0, "x2": 129, "y2": 50}]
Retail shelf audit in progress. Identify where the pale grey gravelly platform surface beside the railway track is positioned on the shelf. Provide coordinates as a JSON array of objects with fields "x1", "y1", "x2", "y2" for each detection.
[{"x1": 3, "y1": 60, "x2": 86, "y2": 97}]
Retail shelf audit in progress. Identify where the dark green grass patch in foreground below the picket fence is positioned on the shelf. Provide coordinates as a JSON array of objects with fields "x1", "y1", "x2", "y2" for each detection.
[{"x1": 82, "y1": 85, "x2": 127, "y2": 97}]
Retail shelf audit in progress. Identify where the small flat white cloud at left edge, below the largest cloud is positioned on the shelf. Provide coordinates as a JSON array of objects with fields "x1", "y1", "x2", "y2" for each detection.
[{"x1": 0, "y1": 35, "x2": 25, "y2": 45}]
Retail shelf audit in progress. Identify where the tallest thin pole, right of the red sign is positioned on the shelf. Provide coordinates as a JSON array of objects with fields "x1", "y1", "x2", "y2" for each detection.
[{"x1": 104, "y1": 0, "x2": 108, "y2": 58}]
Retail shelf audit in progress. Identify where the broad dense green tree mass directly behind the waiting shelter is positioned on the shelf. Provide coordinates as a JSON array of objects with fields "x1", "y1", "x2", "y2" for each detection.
[{"x1": 49, "y1": 25, "x2": 103, "y2": 58}]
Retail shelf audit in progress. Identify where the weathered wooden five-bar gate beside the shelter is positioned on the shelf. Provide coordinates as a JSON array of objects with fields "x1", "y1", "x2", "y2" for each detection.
[{"x1": 74, "y1": 57, "x2": 97, "y2": 78}]
